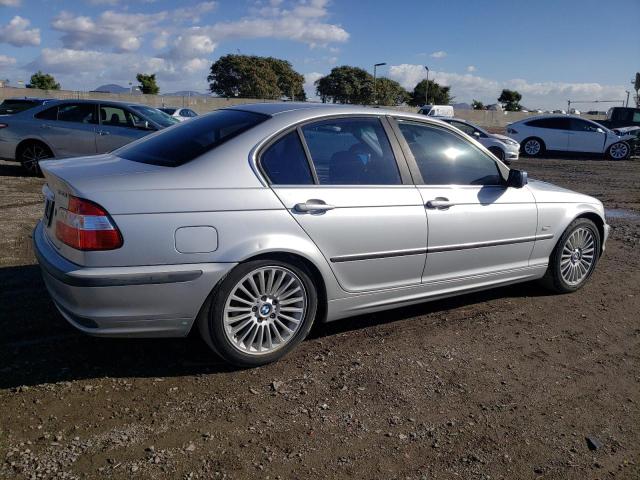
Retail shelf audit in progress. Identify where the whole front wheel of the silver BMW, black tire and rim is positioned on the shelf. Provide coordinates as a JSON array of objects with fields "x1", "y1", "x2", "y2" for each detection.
[{"x1": 542, "y1": 218, "x2": 601, "y2": 293}]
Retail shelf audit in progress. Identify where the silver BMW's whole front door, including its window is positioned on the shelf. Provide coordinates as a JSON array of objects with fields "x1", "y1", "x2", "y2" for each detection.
[{"x1": 397, "y1": 120, "x2": 537, "y2": 283}]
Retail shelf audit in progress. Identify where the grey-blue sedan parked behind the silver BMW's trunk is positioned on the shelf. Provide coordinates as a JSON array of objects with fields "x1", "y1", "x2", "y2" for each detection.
[{"x1": 0, "y1": 100, "x2": 179, "y2": 173}]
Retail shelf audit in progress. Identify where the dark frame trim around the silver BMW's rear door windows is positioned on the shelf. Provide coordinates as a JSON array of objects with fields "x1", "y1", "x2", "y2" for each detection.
[{"x1": 254, "y1": 113, "x2": 415, "y2": 188}]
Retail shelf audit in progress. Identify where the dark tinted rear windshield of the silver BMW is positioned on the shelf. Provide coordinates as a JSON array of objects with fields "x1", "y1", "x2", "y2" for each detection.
[{"x1": 114, "y1": 110, "x2": 269, "y2": 167}]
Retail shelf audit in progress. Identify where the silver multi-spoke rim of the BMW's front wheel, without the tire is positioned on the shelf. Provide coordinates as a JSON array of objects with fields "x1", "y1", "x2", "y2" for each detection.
[{"x1": 560, "y1": 227, "x2": 596, "y2": 287}]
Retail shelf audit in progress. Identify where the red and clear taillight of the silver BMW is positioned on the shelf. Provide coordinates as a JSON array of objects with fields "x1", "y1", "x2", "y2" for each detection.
[{"x1": 56, "y1": 196, "x2": 122, "y2": 250}]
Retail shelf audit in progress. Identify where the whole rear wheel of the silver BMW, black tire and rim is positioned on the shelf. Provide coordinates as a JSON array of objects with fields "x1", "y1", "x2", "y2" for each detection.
[{"x1": 198, "y1": 259, "x2": 318, "y2": 367}]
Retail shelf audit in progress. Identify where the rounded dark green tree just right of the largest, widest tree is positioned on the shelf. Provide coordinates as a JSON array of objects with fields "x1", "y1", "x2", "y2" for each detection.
[{"x1": 315, "y1": 65, "x2": 373, "y2": 105}]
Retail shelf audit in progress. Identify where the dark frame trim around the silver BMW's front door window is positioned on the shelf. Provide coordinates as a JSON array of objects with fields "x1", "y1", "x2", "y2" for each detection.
[{"x1": 388, "y1": 115, "x2": 510, "y2": 189}]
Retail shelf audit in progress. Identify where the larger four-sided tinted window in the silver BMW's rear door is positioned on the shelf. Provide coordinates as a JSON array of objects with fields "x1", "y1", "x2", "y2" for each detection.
[{"x1": 302, "y1": 117, "x2": 402, "y2": 185}]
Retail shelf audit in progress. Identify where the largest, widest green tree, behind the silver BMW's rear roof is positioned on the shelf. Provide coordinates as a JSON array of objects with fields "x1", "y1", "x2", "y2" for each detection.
[{"x1": 207, "y1": 55, "x2": 307, "y2": 101}]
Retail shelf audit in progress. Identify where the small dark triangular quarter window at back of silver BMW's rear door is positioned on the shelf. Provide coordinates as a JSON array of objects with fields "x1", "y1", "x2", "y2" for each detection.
[{"x1": 260, "y1": 131, "x2": 313, "y2": 185}]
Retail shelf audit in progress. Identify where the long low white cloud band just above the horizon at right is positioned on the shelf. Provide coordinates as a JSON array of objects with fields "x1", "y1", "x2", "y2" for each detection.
[{"x1": 389, "y1": 64, "x2": 626, "y2": 109}]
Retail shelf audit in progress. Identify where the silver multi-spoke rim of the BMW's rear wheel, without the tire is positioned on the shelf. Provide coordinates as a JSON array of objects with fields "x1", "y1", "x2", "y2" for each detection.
[{"x1": 223, "y1": 266, "x2": 308, "y2": 355}]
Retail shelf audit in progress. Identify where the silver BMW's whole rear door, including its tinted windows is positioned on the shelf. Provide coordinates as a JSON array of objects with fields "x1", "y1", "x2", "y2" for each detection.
[{"x1": 261, "y1": 116, "x2": 427, "y2": 292}]
